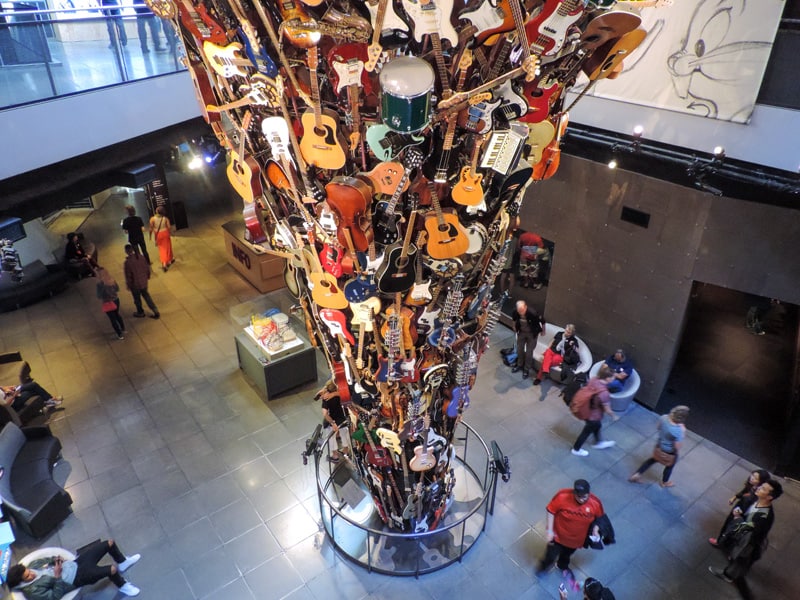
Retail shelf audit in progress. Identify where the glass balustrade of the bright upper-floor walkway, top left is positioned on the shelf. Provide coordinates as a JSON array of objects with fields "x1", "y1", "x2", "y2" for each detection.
[{"x1": 0, "y1": 0, "x2": 184, "y2": 110}]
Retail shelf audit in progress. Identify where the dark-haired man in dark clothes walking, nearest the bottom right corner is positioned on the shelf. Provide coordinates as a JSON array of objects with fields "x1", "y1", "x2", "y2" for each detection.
[{"x1": 708, "y1": 479, "x2": 783, "y2": 600}]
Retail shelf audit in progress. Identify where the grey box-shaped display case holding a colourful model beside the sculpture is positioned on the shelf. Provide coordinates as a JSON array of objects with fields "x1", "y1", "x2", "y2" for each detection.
[{"x1": 231, "y1": 290, "x2": 317, "y2": 400}]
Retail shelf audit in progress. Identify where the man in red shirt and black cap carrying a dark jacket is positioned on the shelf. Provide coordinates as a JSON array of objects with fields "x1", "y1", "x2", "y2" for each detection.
[{"x1": 536, "y1": 479, "x2": 605, "y2": 575}]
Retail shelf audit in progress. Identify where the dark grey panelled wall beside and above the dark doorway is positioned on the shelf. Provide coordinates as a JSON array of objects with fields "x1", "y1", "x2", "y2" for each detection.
[{"x1": 521, "y1": 156, "x2": 800, "y2": 407}]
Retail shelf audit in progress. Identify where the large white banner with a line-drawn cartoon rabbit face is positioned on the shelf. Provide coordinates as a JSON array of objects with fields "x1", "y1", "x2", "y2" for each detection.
[{"x1": 583, "y1": 0, "x2": 785, "y2": 123}]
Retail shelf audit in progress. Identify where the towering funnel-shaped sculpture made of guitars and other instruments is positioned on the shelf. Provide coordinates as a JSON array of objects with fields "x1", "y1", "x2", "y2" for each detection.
[{"x1": 166, "y1": 0, "x2": 648, "y2": 536}]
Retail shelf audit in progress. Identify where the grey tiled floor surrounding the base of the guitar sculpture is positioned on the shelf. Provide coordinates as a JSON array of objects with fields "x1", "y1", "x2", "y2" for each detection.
[{"x1": 0, "y1": 170, "x2": 800, "y2": 600}]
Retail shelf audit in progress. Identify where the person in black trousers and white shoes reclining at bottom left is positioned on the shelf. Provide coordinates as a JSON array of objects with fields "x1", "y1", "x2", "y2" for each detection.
[{"x1": 6, "y1": 540, "x2": 141, "y2": 600}]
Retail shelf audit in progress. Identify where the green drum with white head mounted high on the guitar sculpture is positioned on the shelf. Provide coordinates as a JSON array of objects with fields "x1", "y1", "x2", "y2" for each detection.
[{"x1": 380, "y1": 56, "x2": 434, "y2": 133}]
